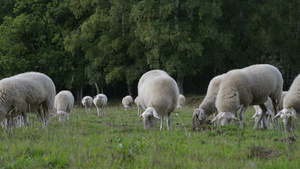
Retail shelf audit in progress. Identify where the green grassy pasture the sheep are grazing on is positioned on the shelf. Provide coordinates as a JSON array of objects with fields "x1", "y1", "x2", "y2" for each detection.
[{"x1": 0, "y1": 97, "x2": 300, "y2": 169}]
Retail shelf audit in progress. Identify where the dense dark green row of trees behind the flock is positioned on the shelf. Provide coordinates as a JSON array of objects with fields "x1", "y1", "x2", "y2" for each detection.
[{"x1": 0, "y1": 0, "x2": 300, "y2": 100}]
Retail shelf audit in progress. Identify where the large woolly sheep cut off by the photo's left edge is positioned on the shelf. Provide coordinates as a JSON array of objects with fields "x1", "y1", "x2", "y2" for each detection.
[{"x1": 0, "y1": 72, "x2": 56, "y2": 128}]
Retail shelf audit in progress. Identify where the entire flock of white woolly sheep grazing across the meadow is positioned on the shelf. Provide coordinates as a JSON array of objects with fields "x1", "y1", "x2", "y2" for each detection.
[{"x1": 0, "y1": 64, "x2": 300, "y2": 132}]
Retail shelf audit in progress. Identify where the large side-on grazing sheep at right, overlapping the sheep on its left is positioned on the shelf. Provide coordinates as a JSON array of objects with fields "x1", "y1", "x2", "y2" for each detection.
[{"x1": 212, "y1": 64, "x2": 283, "y2": 129}]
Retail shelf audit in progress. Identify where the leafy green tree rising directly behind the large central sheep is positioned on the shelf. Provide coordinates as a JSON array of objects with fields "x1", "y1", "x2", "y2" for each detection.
[{"x1": 132, "y1": 0, "x2": 230, "y2": 93}]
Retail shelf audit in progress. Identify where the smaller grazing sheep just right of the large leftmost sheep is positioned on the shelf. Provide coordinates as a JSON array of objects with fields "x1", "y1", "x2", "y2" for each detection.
[{"x1": 54, "y1": 90, "x2": 74, "y2": 122}]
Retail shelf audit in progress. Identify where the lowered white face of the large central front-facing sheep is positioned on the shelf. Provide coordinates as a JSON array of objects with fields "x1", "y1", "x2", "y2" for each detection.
[{"x1": 140, "y1": 107, "x2": 159, "y2": 129}]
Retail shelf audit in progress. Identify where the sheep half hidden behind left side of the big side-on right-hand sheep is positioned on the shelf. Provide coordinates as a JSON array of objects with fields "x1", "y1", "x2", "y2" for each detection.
[{"x1": 193, "y1": 74, "x2": 224, "y2": 131}]
